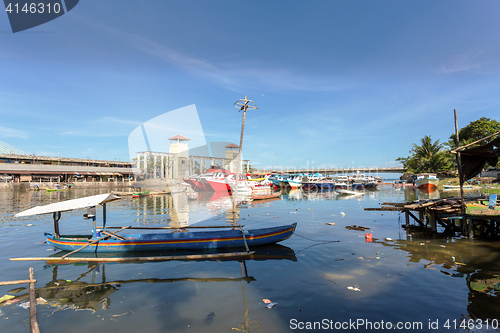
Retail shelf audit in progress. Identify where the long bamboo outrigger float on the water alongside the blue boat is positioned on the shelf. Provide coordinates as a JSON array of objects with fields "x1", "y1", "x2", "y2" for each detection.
[{"x1": 10, "y1": 251, "x2": 255, "y2": 262}]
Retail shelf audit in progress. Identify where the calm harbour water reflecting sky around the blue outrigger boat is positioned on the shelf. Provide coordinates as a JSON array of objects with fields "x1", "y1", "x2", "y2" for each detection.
[{"x1": 0, "y1": 186, "x2": 500, "y2": 333}]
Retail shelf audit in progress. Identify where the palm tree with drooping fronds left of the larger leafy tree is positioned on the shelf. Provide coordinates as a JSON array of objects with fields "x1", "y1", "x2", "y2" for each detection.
[{"x1": 396, "y1": 135, "x2": 450, "y2": 173}]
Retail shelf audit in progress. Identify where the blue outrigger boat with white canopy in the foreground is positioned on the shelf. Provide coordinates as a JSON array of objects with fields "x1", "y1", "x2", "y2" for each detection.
[{"x1": 15, "y1": 194, "x2": 297, "y2": 253}]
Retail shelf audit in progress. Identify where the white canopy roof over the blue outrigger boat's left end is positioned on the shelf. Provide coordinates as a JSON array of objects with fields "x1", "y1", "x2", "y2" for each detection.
[{"x1": 14, "y1": 193, "x2": 121, "y2": 217}]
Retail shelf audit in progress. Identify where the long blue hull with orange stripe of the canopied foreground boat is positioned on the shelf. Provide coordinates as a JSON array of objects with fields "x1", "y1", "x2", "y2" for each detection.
[{"x1": 45, "y1": 223, "x2": 297, "y2": 253}]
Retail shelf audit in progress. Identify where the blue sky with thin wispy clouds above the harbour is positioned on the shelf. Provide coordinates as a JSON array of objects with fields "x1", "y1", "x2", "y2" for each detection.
[{"x1": 0, "y1": 0, "x2": 500, "y2": 168}]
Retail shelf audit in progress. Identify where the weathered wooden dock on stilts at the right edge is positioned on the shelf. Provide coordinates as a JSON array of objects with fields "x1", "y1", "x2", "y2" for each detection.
[{"x1": 365, "y1": 196, "x2": 500, "y2": 239}]
